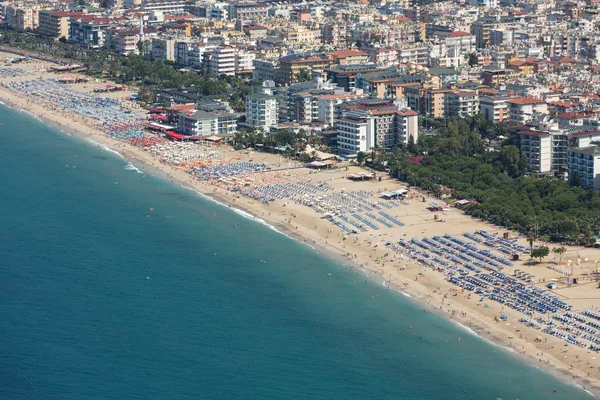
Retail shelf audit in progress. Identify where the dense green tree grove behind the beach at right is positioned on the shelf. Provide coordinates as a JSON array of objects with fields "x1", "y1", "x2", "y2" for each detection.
[{"x1": 371, "y1": 118, "x2": 600, "y2": 245}]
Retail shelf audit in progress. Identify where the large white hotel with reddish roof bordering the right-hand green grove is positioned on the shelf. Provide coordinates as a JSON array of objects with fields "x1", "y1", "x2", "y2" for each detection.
[{"x1": 336, "y1": 99, "x2": 419, "y2": 156}]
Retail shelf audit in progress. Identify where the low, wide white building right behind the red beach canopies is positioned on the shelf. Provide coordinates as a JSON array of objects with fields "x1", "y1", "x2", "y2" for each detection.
[{"x1": 177, "y1": 110, "x2": 237, "y2": 136}]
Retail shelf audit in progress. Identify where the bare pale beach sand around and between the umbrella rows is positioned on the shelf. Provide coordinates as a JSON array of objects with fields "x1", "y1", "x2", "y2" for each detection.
[{"x1": 0, "y1": 53, "x2": 600, "y2": 394}]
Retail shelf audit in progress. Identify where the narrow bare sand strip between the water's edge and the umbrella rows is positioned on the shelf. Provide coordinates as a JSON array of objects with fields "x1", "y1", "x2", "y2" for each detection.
[{"x1": 0, "y1": 61, "x2": 600, "y2": 396}]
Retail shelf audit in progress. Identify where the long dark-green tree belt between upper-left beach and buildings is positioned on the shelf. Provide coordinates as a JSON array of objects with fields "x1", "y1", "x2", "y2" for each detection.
[{"x1": 1, "y1": 31, "x2": 251, "y2": 110}]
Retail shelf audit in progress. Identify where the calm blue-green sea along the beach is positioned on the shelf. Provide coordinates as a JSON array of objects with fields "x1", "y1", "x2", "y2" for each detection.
[{"x1": 0, "y1": 106, "x2": 593, "y2": 400}]
